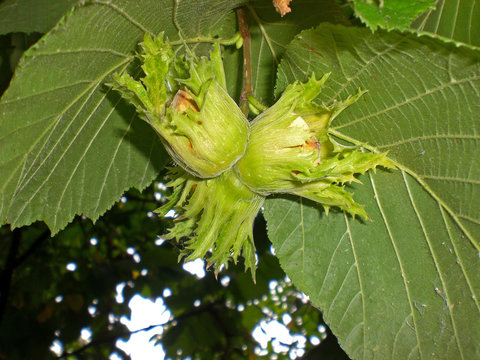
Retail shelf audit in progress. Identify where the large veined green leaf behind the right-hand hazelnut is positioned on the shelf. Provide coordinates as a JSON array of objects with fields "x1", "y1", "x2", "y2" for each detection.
[{"x1": 265, "y1": 25, "x2": 480, "y2": 359}]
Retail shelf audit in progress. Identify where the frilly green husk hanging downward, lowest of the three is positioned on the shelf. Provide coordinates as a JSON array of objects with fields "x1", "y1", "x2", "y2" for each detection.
[{"x1": 157, "y1": 167, "x2": 265, "y2": 278}]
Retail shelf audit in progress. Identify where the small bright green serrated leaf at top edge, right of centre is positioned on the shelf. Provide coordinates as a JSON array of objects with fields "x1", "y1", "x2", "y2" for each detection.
[{"x1": 351, "y1": 0, "x2": 434, "y2": 30}]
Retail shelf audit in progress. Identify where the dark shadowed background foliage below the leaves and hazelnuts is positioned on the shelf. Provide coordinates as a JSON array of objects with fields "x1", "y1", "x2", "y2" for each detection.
[{"x1": 0, "y1": 171, "x2": 348, "y2": 359}]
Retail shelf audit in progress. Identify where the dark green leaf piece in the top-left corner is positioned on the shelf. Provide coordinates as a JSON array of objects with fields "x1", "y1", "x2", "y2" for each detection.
[{"x1": 0, "y1": 0, "x2": 76, "y2": 34}]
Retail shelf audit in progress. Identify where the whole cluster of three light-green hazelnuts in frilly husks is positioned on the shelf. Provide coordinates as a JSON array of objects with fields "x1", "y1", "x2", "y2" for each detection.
[{"x1": 112, "y1": 34, "x2": 393, "y2": 277}]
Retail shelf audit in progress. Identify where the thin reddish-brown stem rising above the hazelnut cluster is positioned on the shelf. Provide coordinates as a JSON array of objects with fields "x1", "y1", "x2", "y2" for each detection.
[{"x1": 237, "y1": 7, "x2": 253, "y2": 116}]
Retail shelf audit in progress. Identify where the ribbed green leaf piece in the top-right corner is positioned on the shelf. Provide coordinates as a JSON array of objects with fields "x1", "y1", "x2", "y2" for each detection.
[{"x1": 412, "y1": 0, "x2": 480, "y2": 46}]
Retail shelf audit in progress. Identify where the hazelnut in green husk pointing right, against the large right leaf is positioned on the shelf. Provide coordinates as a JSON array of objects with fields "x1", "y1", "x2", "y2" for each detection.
[{"x1": 234, "y1": 74, "x2": 394, "y2": 218}]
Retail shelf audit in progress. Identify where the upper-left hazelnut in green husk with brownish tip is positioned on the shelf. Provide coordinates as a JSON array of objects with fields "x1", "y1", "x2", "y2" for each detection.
[{"x1": 112, "y1": 34, "x2": 249, "y2": 178}]
